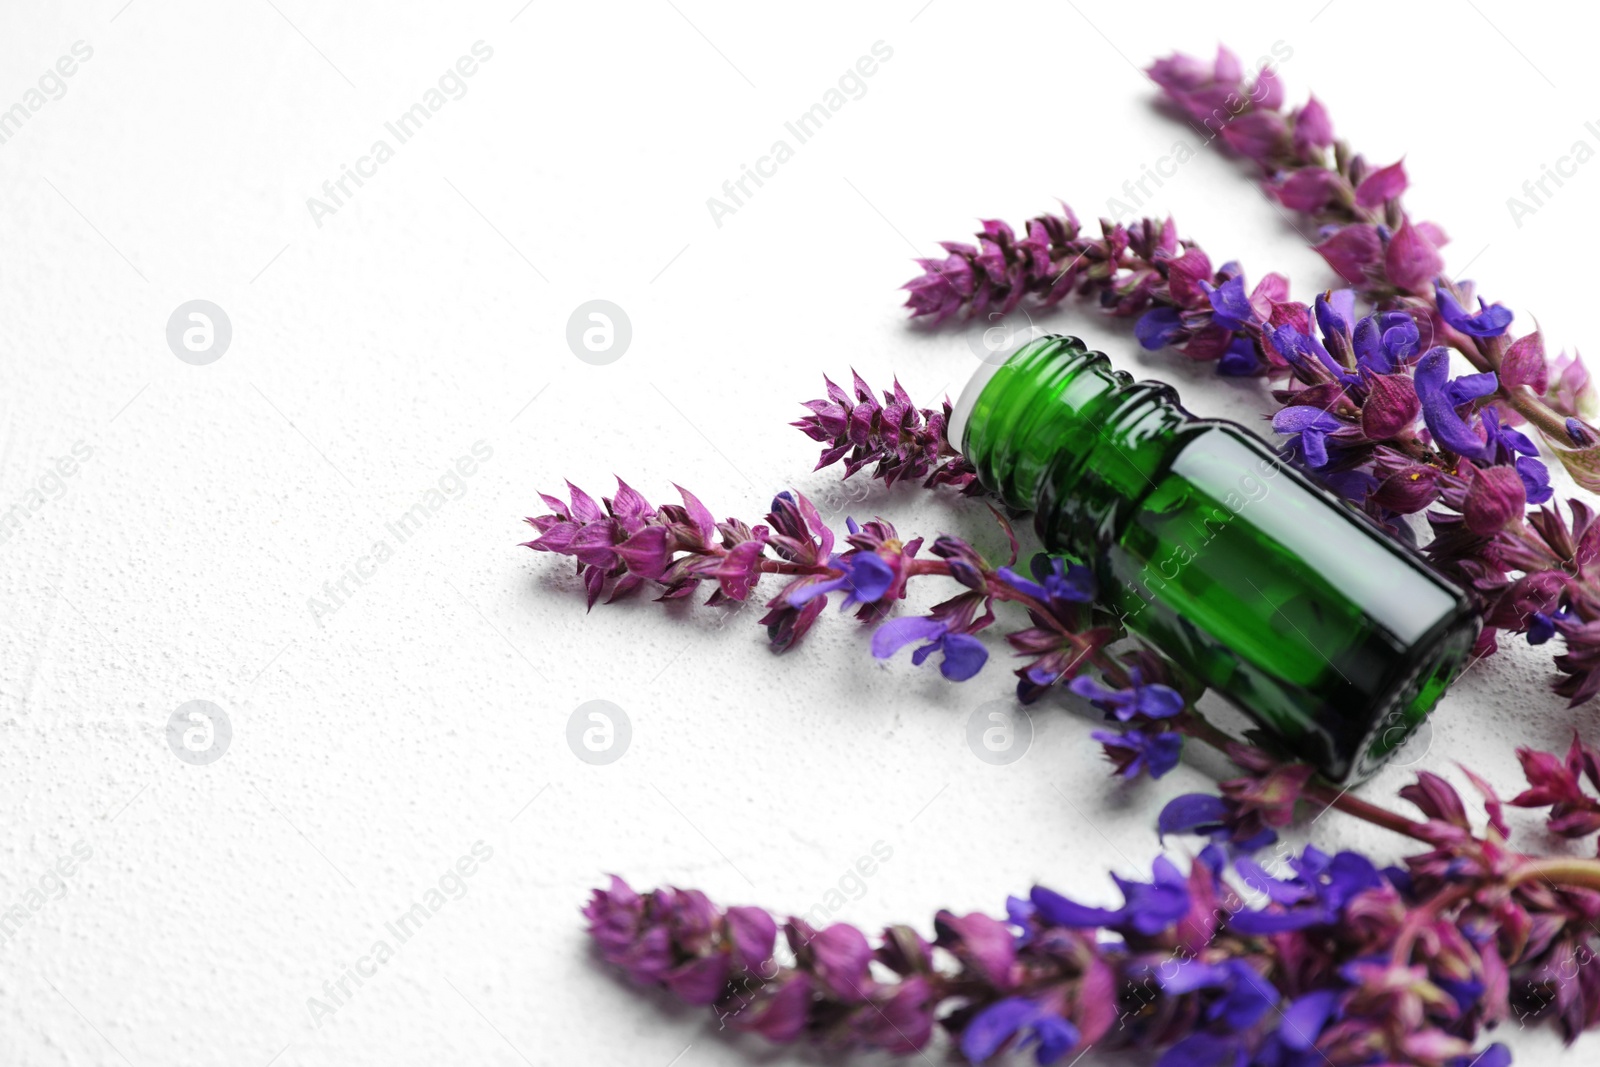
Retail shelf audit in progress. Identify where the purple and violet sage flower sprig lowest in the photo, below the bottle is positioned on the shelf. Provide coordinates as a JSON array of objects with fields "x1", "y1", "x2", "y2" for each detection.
[{"x1": 584, "y1": 741, "x2": 1600, "y2": 1067}]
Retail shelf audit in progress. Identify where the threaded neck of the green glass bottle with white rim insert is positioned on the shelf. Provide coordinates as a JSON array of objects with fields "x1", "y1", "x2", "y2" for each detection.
[{"x1": 960, "y1": 334, "x2": 1192, "y2": 552}]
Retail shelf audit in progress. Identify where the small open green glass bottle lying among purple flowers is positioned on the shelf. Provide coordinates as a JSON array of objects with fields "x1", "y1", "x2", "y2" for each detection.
[{"x1": 950, "y1": 336, "x2": 1478, "y2": 782}]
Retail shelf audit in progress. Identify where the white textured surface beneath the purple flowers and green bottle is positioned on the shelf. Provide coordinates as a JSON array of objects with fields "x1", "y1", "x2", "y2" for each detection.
[{"x1": 0, "y1": 0, "x2": 1600, "y2": 1067}]
